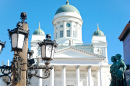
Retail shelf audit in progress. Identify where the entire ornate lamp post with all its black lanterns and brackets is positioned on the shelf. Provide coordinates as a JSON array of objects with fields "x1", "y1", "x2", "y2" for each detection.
[{"x1": 0, "y1": 12, "x2": 57, "y2": 86}]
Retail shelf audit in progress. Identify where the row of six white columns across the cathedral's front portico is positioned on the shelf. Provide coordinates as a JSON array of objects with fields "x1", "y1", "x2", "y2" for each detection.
[{"x1": 38, "y1": 65, "x2": 102, "y2": 86}]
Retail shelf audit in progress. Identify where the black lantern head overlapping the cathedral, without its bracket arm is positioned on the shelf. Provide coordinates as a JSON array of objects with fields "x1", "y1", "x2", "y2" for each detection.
[{"x1": 38, "y1": 34, "x2": 57, "y2": 61}]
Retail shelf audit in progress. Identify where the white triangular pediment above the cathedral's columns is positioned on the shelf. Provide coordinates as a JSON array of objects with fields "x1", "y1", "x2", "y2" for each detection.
[{"x1": 54, "y1": 47, "x2": 105, "y2": 59}]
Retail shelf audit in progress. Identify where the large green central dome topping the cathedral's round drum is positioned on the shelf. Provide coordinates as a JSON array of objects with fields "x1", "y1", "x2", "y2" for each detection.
[{"x1": 55, "y1": 1, "x2": 80, "y2": 15}]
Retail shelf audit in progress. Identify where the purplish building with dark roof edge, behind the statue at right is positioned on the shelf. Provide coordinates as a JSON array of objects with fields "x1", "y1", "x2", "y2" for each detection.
[{"x1": 118, "y1": 21, "x2": 130, "y2": 86}]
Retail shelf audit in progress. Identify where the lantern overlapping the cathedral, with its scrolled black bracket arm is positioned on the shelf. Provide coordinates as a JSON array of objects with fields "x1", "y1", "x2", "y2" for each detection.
[{"x1": 28, "y1": 34, "x2": 57, "y2": 84}]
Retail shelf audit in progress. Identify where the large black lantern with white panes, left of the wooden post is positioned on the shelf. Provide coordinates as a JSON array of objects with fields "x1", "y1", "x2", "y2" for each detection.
[{"x1": 8, "y1": 22, "x2": 28, "y2": 51}]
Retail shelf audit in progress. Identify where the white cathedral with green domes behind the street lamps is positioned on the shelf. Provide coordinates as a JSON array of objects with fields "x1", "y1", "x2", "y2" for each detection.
[{"x1": 30, "y1": 1, "x2": 110, "y2": 86}]
